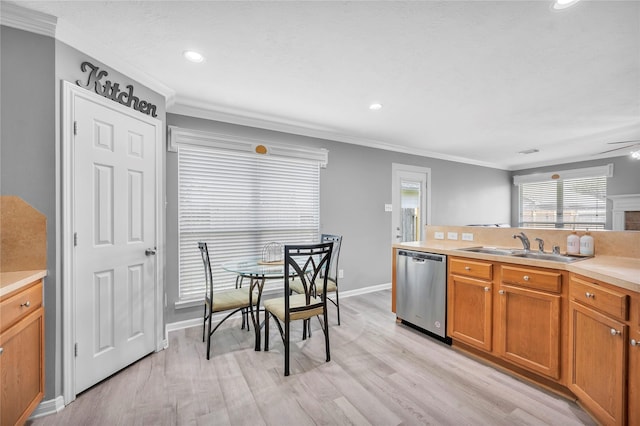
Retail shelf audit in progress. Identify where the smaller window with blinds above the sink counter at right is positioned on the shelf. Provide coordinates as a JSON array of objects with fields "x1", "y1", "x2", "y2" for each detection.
[{"x1": 518, "y1": 176, "x2": 607, "y2": 229}]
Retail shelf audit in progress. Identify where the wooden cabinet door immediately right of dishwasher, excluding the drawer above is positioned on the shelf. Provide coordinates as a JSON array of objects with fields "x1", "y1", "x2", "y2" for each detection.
[{"x1": 447, "y1": 275, "x2": 492, "y2": 351}]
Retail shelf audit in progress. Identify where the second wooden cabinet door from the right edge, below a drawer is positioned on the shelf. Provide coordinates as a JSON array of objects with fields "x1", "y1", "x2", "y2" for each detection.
[{"x1": 569, "y1": 301, "x2": 628, "y2": 425}]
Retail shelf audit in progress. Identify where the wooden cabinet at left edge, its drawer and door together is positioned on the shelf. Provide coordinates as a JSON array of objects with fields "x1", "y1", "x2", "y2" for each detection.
[{"x1": 0, "y1": 279, "x2": 44, "y2": 425}]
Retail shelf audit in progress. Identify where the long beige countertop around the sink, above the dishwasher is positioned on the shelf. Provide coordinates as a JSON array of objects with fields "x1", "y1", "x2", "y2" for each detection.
[{"x1": 393, "y1": 240, "x2": 640, "y2": 293}]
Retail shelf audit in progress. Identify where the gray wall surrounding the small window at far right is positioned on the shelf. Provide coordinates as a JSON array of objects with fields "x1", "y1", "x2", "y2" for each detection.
[{"x1": 511, "y1": 156, "x2": 640, "y2": 229}]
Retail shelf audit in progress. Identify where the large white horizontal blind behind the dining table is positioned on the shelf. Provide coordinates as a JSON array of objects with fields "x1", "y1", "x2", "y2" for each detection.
[{"x1": 178, "y1": 144, "x2": 320, "y2": 301}]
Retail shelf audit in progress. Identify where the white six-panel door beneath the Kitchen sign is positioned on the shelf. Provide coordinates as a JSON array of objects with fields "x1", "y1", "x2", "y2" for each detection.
[{"x1": 72, "y1": 91, "x2": 159, "y2": 393}]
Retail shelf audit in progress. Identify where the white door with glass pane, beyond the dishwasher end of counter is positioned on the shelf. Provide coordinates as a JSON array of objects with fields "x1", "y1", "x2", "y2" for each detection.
[{"x1": 391, "y1": 164, "x2": 431, "y2": 242}]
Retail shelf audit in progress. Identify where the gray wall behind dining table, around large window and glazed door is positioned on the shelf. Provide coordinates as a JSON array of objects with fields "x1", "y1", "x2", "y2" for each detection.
[{"x1": 166, "y1": 114, "x2": 511, "y2": 323}]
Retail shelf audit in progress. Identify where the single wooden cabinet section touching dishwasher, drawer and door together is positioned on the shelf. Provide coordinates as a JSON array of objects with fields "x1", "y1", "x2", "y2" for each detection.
[{"x1": 447, "y1": 258, "x2": 493, "y2": 351}]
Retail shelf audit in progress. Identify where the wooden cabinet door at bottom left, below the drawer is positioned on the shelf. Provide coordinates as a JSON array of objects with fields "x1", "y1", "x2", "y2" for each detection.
[{"x1": 0, "y1": 307, "x2": 44, "y2": 425}]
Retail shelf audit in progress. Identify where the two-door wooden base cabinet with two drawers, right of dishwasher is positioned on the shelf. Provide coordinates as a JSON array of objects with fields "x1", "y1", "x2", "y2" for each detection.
[{"x1": 447, "y1": 257, "x2": 566, "y2": 381}]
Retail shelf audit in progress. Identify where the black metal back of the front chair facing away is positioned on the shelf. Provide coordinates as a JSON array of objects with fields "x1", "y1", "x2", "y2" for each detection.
[{"x1": 284, "y1": 242, "x2": 333, "y2": 312}]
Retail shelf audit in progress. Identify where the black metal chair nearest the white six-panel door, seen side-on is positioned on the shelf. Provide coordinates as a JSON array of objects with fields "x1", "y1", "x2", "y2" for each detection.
[{"x1": 198, "y1": 242, "x2": 257, "y2": 359}]
